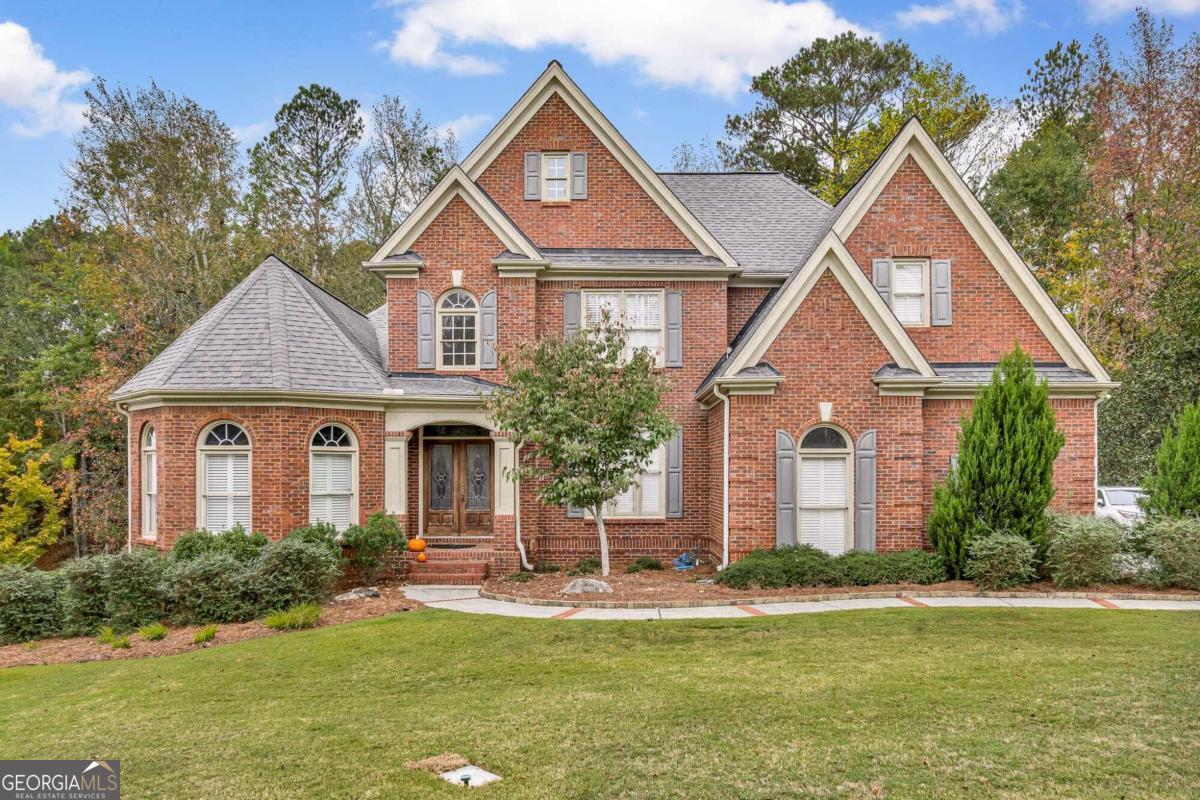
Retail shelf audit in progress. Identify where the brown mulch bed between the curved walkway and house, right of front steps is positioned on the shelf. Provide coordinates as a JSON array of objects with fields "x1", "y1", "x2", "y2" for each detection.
[{"x1": 482, "y1": 567, "x2": 1200, "y2": 604}]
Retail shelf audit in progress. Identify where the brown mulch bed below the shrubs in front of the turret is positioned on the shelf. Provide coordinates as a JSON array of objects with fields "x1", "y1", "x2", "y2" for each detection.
[{"x1": 0, "y1": 587, "x2": 422, "y2": 668}]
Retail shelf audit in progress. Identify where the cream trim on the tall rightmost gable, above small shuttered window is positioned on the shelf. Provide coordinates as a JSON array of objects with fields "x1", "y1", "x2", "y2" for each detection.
[{"x1": 833, "y1": 119, "x2": 1111, "y2": 383}]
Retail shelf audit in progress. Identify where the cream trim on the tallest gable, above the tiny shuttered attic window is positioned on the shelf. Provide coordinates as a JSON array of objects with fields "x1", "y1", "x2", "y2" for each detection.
[{"x1": 462, "y1": 61, "x2": 737, "y2": 267}]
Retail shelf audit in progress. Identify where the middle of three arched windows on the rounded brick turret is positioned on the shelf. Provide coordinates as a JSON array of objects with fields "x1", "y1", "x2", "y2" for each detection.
[{"x1": 197, "y1": 422, "x2": 251, "y2": 533}]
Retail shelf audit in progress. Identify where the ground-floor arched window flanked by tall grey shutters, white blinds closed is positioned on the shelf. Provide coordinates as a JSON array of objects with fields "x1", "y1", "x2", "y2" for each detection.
[{"x1": 797, "y1": 425, "x2": 854, "y2": 555}]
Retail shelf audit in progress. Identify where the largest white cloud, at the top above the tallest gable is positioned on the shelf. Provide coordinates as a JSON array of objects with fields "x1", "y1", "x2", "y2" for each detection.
[{"x1": 386, "y1": 0, "x2": 865, "y2": 96}]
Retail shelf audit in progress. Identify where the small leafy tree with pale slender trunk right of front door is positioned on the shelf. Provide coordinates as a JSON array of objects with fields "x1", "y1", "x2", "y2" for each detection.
[{"x1": 486, "y1": 317, "x2": 676, "y2": 576}]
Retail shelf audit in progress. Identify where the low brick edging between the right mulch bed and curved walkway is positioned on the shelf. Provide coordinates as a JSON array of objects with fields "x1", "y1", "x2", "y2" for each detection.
[{"x1": 479, "y1": 588, "x2": 1200, "y2": 608}]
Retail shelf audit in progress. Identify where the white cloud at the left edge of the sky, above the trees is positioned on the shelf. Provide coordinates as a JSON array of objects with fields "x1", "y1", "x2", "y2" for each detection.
[{"x1": 0, "y1": 22, "x2": 91, "y2": 137}]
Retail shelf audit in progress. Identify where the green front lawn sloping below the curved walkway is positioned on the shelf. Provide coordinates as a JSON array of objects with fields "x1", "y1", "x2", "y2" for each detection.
[{"x1": 0, "y1": 609, "x2": 1200, "y2": 800}]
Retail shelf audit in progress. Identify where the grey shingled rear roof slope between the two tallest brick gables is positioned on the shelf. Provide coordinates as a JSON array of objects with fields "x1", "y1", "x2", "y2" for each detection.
[{"x1": 659, "y1": 173, "x2": 832, "y2": 277}]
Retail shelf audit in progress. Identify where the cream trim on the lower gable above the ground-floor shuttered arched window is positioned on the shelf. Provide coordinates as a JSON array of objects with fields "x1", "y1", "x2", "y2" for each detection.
[{"x1": 724, "y1": 233, "x2": 937, "y2": 378}]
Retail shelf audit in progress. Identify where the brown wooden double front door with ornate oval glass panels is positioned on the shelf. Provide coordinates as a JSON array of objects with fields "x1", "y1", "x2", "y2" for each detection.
[{"x1": 424, "y1": 439, "x2": 493, "y2": 536}]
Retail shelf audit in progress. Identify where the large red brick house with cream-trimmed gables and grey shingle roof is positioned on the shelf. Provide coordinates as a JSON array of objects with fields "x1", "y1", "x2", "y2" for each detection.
[{"x1": 114, "y1": 62, "x2": 1114, "y2": 579}]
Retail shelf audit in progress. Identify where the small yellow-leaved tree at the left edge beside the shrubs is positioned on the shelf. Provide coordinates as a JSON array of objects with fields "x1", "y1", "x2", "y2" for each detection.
[{"x1": 0, "y1": 421, "x2": 65, "y2": 564}]
